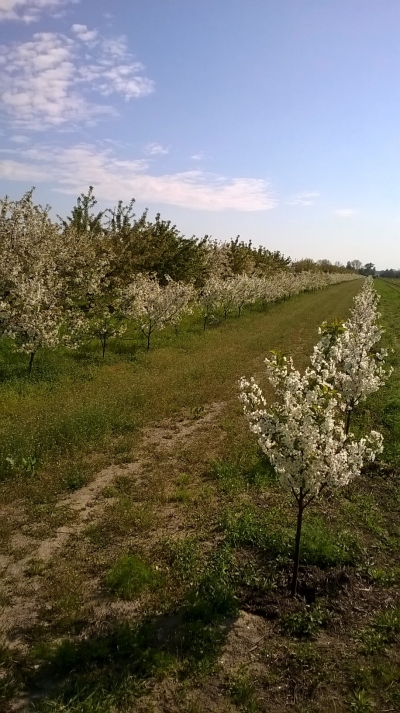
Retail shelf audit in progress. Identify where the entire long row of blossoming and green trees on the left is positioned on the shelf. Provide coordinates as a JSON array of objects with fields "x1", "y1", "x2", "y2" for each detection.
[{"x1": 0, "y1": 189, "x2": 355, "y2": 369}]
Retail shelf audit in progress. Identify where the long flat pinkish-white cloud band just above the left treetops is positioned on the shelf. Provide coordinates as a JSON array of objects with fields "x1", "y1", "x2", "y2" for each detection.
[{"x1": 0, "y1": 144, "x2": 276, "y2": 211}]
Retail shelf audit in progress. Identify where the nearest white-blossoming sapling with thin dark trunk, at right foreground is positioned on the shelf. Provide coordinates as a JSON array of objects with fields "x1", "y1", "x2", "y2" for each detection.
[{"x1": 239, "y1": 353, "x2": 382, "y2": 595}]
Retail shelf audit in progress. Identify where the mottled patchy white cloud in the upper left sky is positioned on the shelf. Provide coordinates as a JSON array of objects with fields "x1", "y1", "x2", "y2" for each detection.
[{"x1": 0, "y1": 27, "x2": 154, "y2": 130}]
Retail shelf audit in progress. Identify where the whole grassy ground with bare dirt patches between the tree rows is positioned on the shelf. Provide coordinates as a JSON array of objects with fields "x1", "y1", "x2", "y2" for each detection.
[{"x1": 0, "y1": 280, "x2": 400, "y2": 713}]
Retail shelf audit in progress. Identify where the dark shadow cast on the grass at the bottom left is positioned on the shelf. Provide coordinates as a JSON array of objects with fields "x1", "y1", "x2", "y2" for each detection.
[{"x1": 27, "y1": 595, "x2": 236, "y2": 713}]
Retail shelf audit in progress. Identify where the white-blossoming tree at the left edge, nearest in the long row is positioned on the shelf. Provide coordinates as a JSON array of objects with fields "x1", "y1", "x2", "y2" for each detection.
[{"x1": 0, "y1": 191, "x2": 65, "y2": 372}]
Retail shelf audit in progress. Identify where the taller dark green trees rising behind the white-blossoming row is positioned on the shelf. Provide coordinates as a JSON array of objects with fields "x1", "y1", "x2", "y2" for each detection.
[{"x1": 56, "y1": 187, "x2": 354, "y2": 287}]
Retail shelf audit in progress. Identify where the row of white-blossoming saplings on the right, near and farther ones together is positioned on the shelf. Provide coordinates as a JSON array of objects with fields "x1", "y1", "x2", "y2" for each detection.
[{"x1": 239, "y1": 277, "x2": 390, "y2": 595}]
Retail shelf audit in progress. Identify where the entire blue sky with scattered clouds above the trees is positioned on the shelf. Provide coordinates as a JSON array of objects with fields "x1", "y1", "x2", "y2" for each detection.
[{"x1": 0, "y1": 0, "x2": 400, "y2": 269}]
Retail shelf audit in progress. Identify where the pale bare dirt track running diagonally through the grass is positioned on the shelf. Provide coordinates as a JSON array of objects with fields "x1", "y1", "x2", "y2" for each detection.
[{"x1": 0, "y1": 403, "x2": 224, "y2": 648}]
